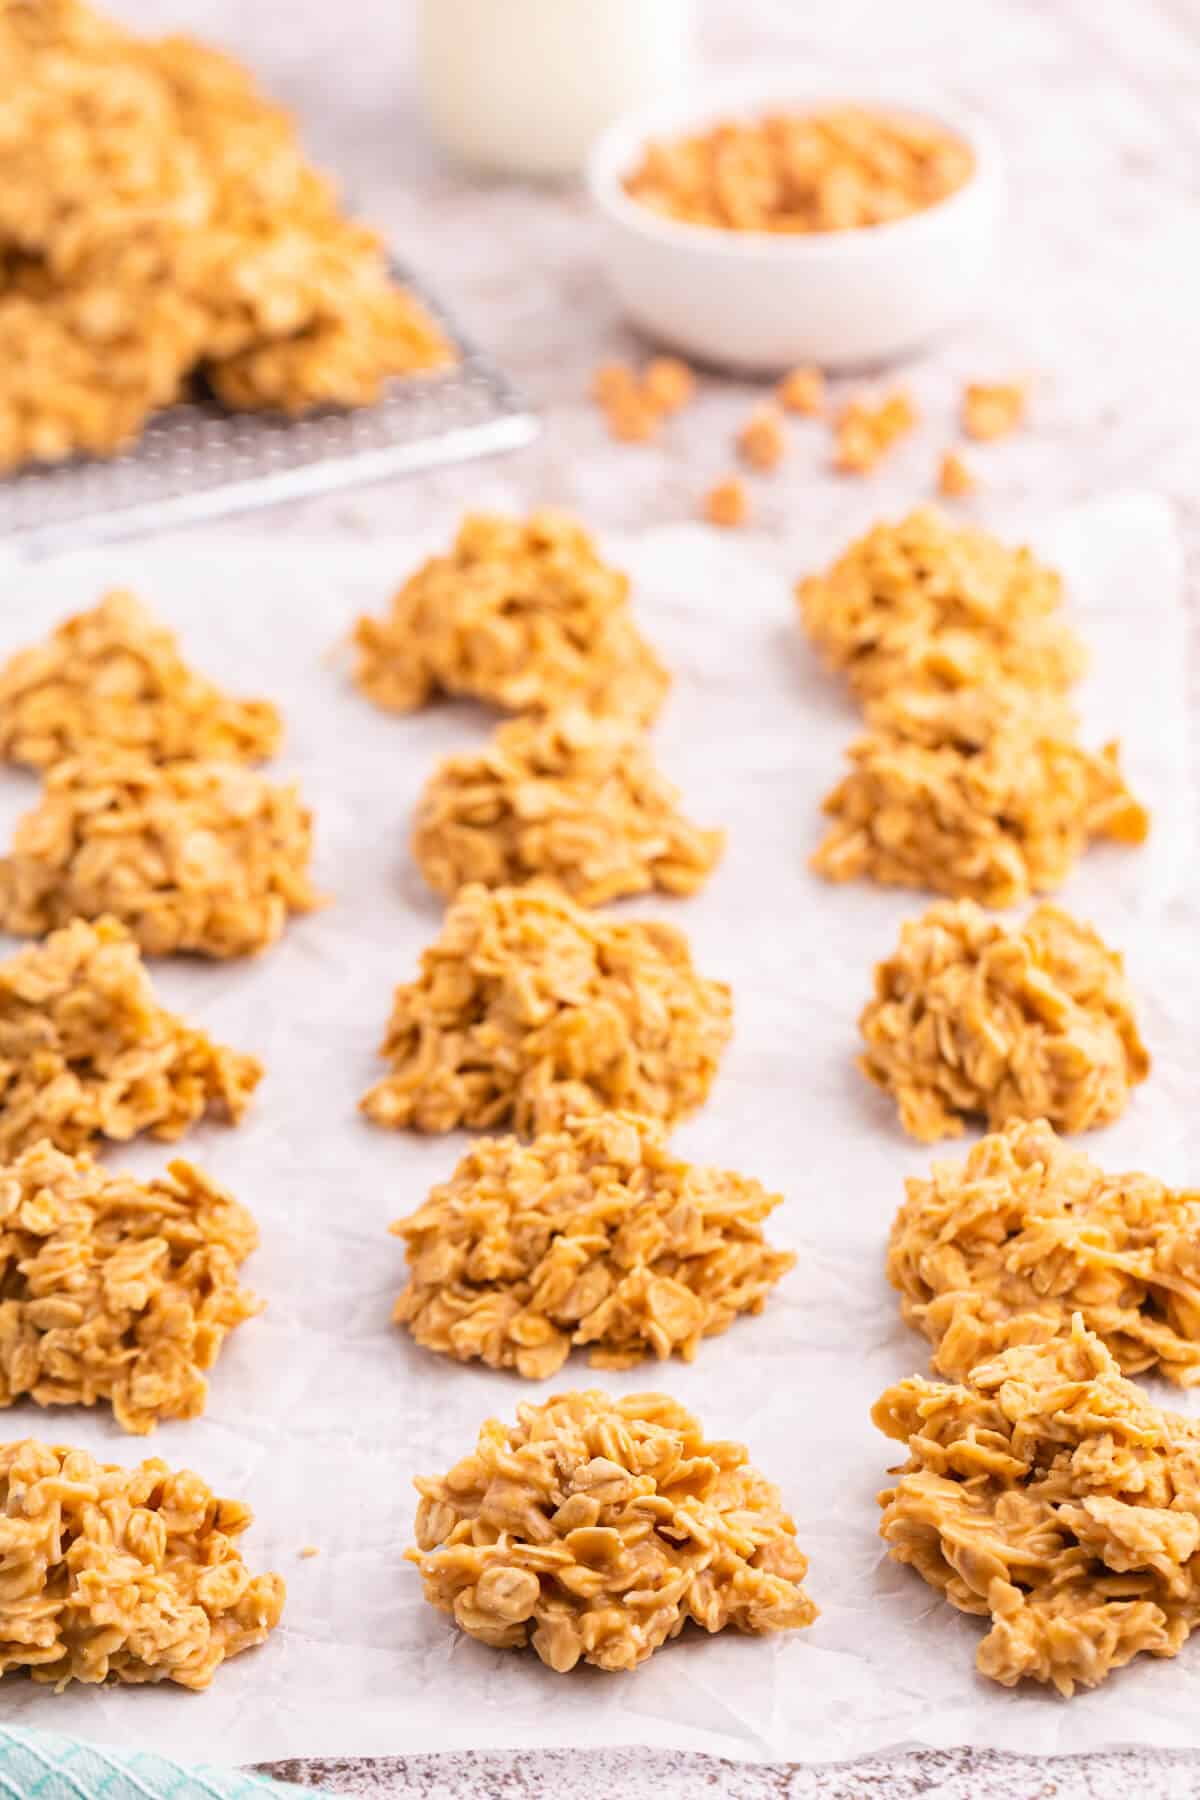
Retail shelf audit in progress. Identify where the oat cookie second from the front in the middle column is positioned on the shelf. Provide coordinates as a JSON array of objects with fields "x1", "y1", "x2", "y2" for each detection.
[{"x1": 392, "y1": 1112, "x2": 795, "y2": 1381}]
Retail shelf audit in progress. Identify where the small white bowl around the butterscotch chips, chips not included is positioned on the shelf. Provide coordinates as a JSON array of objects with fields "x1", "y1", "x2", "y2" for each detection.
[{"x1": 587, "y1": 85, "x2": 1004, "y2": 373}]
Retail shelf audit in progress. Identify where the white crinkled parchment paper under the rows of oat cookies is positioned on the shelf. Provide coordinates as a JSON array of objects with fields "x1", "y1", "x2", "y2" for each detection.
[{"x1": 0, "y1": 499, "x2": 1200, "y2": 1762}]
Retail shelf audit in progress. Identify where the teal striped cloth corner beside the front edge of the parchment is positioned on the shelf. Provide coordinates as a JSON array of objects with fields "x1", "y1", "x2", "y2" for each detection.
[{"x1": 0, "y1": 1724, "x2": 320, "y2": 1800}]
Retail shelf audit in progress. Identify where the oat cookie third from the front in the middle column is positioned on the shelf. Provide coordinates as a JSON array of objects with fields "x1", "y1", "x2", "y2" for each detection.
[{"x1": 362, "y1": 886, "x2": 732, "y2": 1132}]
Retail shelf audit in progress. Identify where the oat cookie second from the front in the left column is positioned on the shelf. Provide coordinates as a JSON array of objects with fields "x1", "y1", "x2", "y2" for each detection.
[{"x1": 0, "y1": 1141, "x2": 263, "y2": 1433}]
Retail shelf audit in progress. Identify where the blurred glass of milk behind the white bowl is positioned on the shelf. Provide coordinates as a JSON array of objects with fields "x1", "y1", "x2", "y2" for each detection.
[{"x1": 417, "y1": 0, "x2": 694, "y2": 176}]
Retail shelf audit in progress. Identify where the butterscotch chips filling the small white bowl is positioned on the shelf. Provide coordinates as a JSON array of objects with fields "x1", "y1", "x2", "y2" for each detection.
[{"x1": 624, "y1": 106, "x2": 975, "y2": 232}]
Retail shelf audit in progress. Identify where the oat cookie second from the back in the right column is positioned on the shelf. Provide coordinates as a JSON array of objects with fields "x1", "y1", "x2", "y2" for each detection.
[{"x1": 811, "y1": 689, "x2": 1150, "y2": 907}]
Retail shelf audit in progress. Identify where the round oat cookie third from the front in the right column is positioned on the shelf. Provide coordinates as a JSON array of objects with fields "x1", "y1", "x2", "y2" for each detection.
[{"x1": 858, "y1": 900, "x2": 1150, "y2": 1143}]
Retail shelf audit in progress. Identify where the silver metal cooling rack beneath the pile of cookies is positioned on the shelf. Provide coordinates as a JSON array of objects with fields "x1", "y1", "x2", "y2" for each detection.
[{"x1": 0, "y1": 268, "x2": 538, "y2": 556}]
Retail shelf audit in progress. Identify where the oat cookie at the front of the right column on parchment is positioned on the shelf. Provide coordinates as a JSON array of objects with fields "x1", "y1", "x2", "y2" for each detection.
[{"x1": 873, "y1": 1314, "x2": 1200, "y2": 1696}]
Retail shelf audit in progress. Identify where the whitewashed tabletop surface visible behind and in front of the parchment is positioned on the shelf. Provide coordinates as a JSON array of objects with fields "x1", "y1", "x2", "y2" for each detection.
[{"x1": 113, "y1": 0, "x2": 1200, "y2": 1800}]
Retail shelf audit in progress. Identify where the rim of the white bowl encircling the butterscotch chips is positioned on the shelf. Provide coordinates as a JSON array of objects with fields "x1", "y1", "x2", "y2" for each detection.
[{"x1": 587, "y1": 79, "x2": 999, "y2": 261}]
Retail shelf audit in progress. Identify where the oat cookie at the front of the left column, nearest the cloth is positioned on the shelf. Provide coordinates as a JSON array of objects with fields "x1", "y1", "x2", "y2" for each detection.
[{"x1": 0, "y1": 1438, "x2": 286, "y2": 1688}]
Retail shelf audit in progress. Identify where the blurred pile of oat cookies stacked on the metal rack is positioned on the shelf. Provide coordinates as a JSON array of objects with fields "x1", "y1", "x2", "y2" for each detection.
[{"x1": 0, "y1": 0, "x2": 452, "y2": 470}]
